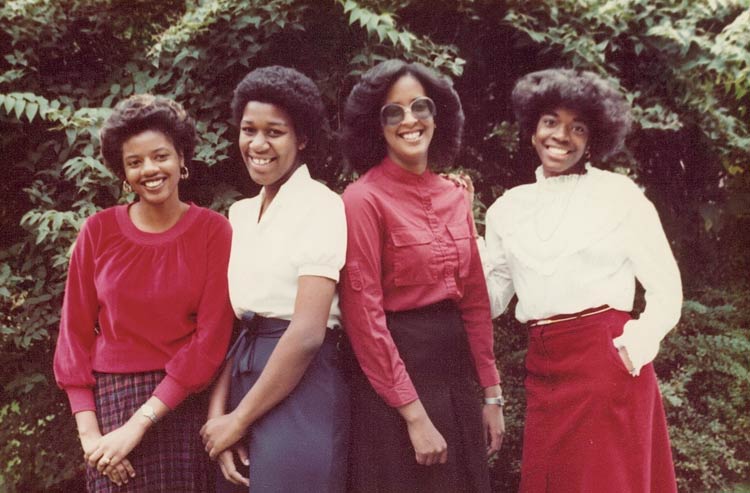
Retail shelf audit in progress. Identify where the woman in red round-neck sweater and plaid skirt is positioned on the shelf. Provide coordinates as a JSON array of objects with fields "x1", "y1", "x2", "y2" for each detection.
[{"x1": 54, "y1": 95, "x2": 232, "y2": 492}]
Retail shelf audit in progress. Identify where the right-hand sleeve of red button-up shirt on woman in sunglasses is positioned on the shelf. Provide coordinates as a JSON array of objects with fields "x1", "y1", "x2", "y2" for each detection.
[{"x1": 458, "y1": 206, "x2": 500, "y2": 387}]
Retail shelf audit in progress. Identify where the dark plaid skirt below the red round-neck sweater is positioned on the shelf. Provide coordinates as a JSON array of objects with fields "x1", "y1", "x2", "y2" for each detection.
[{"x1": 86, "y1": 371, "x2": 214, "y2": 493}]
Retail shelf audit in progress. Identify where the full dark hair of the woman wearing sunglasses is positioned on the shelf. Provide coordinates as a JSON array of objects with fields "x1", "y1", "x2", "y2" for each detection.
[{"x1": 341, "y1": 59, "x2": 464, "y2": 173}]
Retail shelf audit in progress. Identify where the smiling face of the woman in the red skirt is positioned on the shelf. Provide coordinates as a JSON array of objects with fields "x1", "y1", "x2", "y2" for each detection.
[{"x1": 531, "y1": 108, "x2": 589, "y2": 177}]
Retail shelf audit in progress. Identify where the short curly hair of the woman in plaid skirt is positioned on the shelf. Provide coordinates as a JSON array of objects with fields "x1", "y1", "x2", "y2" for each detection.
[{"x1": 99, "y1": 94, "x2": 197, "y2": 179}]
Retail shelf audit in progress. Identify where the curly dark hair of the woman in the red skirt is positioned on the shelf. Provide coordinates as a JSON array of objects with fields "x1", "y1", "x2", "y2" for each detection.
[{"x1": 511, "y1": 69, "x2": 632, "y2": 159}]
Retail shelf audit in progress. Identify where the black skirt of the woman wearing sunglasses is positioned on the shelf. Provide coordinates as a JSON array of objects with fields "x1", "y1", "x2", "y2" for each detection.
[{"x1": 349, "y1": 301, "x2": 490, "y2": 493}]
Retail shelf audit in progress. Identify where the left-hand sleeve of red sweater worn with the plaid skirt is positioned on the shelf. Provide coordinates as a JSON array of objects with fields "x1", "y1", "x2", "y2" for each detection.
[{"x1": 53, "y1": 216, "x2": 99, "y2": 413}]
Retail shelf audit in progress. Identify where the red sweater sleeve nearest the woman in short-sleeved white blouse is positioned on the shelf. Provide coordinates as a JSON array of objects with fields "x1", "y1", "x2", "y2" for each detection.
[{"x1": 153, "y1": 213, "x2": 234, "y2": 409}]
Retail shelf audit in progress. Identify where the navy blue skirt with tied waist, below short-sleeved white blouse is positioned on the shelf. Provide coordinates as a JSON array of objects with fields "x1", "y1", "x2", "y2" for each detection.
[{"x1": 217, "y1": 317, "x2": 350, "y2": 493}]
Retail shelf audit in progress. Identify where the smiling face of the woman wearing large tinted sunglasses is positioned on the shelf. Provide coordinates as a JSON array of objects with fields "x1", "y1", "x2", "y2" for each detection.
[{"x1": 382, "y1": 74, "x2": 435, "y2": 173}]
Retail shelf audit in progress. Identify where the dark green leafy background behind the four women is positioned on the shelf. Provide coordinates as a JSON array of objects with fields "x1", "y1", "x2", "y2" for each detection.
[{"x1": 0, "y1": 0, "x2": 750, "y2": 492}]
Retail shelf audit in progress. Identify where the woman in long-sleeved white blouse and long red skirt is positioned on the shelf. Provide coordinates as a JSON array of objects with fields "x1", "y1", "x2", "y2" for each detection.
[{"x1": 484, "y1": 69, "x2": 682, "y2": 493}]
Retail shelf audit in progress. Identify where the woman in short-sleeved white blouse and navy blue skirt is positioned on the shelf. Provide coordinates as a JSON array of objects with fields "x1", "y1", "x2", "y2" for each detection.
[{"x1": 201, "y1": 66, "x2": 349, "y2": 492}]
